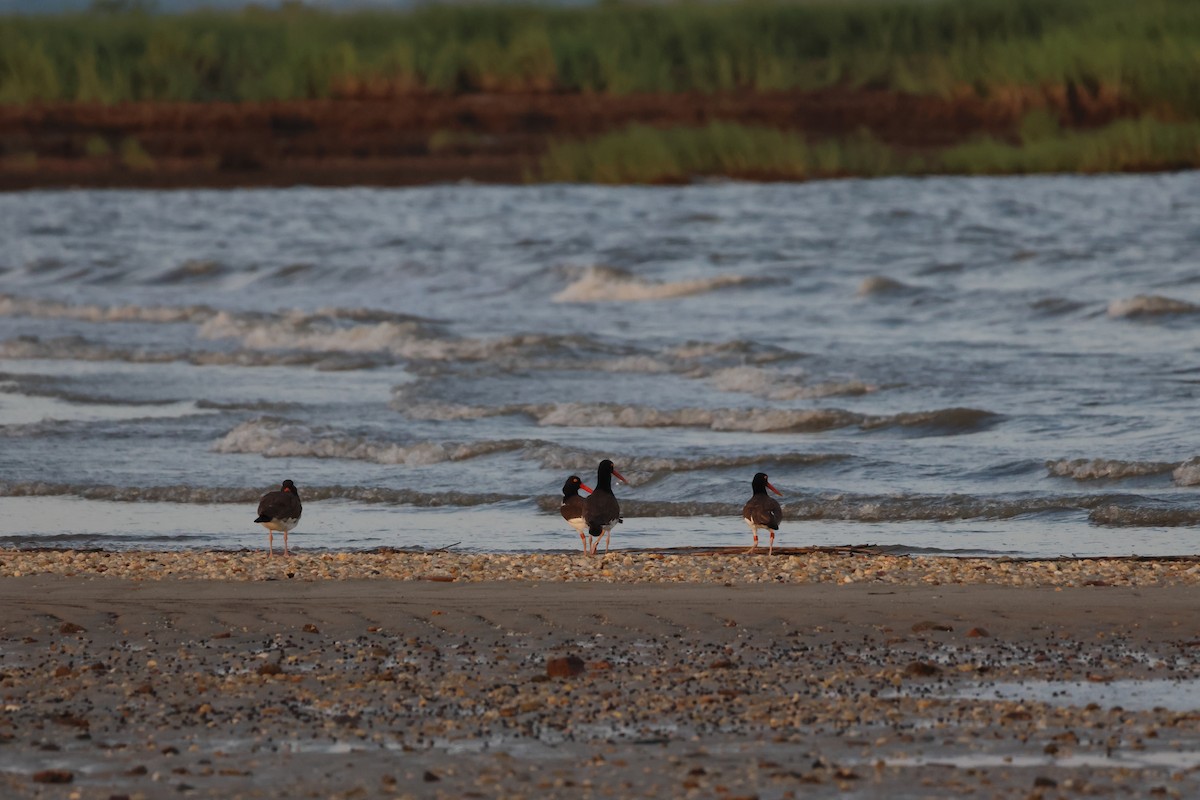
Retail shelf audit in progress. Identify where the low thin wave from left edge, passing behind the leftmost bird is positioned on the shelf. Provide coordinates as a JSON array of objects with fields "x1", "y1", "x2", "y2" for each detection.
[{"x1": 0, "y1": 481, "x2": 520, "y2": 509}]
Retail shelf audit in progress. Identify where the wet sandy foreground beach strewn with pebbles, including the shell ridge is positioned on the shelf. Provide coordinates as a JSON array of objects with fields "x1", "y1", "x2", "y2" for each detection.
[{"x1": 0, "y1": 551, "x2": 1200, "y2": 798}]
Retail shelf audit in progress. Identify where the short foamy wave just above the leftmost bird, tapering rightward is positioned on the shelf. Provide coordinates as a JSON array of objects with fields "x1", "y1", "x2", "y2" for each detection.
[{"x1": 212, "y1": 417, "x2": 527, "y2": 465}]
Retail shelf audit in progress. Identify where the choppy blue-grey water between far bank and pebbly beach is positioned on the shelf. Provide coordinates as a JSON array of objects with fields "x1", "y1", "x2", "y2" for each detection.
[{"x1": 0, "y1": 173, "x2": 1200, "y2": 557}]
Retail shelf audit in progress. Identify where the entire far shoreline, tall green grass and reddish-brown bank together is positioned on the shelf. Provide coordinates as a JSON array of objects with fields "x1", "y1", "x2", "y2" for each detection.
[{"x1": 0, "y1": 0, "x2": 1200, "y2": 184}]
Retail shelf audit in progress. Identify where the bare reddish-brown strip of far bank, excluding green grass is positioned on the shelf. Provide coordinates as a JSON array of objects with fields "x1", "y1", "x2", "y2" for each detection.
[{"x1": 0, "y1": 89, "x2": 1136, "y2": 190}]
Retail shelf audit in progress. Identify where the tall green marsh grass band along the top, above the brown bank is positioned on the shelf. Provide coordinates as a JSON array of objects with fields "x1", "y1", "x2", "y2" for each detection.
[{"x1": 0, "y1": 0, "x2": 1200, "y2": 113}]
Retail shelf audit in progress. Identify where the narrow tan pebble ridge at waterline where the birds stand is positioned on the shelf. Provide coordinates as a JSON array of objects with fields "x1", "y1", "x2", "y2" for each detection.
[{"x1": 0, "y1": 549, "x2": 1200, "y2": 587}]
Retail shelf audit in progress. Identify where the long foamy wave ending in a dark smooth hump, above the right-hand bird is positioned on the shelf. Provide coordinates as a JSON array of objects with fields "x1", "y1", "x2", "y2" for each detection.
[{"x1": 392, "y1": 398, "x2": 1000, "y2": 433}]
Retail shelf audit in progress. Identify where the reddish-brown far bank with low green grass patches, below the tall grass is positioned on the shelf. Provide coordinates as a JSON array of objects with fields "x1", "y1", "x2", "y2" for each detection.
[{"x1": 0, "y1": 89, "x2": 1200, "y2": 191}]
